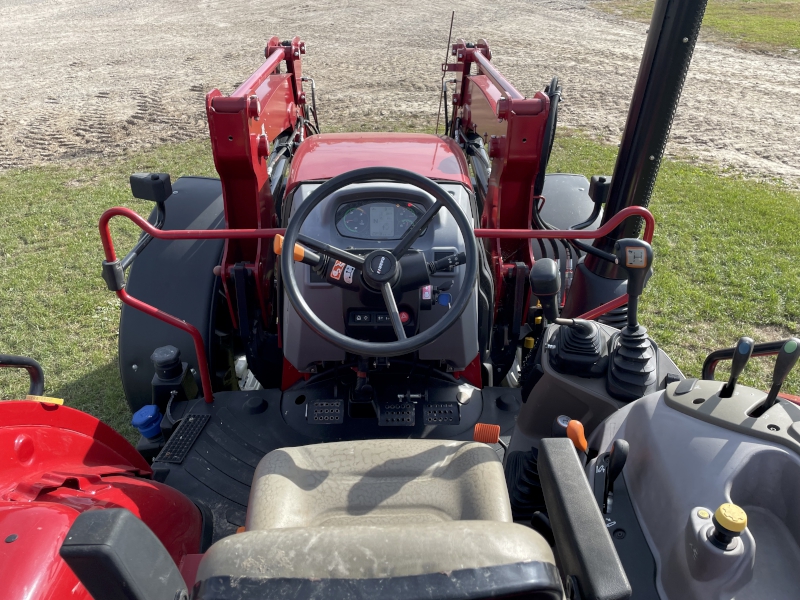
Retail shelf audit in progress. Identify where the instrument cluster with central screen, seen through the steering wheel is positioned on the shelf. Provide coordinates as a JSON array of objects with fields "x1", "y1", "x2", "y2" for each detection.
[{"x1": 336, "y1": 200, "x2": 425, "y2": 240}]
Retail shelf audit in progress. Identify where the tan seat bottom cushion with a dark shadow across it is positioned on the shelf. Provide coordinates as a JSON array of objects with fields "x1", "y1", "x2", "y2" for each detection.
[{"x1": 245, "y1": 440, "x2": 511, "y2": 531}]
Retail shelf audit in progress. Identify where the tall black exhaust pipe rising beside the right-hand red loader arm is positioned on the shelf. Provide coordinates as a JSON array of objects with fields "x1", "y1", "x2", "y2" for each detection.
[{"x1": 564, "y1": 0, "x2": 707, "y2": 316}]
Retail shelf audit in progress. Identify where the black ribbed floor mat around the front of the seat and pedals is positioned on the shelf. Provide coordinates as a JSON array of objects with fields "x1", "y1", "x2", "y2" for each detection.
[{"x1": 153, "y1": 383, "x2": 521, "y2": 541}]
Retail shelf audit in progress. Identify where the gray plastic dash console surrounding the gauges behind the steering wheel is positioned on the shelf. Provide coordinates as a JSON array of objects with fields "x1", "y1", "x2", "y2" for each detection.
[{"x1": 283, "y1": 183, "x2": 478, "y2": 371}]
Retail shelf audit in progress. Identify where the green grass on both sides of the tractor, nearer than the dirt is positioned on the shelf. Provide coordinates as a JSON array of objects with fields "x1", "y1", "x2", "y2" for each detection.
[{"x1": 0, "y1": 131, "x2": 800, "y2": 437}]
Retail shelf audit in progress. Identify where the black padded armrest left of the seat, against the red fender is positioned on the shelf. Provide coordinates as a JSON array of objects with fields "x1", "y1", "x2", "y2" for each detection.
[{"x1": 60, "y1": 508, "x2": 187, "y2": 600}]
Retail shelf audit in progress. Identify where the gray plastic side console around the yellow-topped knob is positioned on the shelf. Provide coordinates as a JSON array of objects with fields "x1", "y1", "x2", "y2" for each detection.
[{"x1": 588, "y1": 392, "x2": 800, "y2": 600}]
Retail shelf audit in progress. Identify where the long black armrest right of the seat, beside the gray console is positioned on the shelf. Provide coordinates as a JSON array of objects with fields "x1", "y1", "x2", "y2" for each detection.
[{"x1": 538, "y1": 438, "x2": 632, "y2": 600}]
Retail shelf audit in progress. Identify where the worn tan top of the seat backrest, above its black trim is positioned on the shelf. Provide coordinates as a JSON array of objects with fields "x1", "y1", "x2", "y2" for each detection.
[{"x1": 197, "y1": 521, "x2": 557, "y2": 581}]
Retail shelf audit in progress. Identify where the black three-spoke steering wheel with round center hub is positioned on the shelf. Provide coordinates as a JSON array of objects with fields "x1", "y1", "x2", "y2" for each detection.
[{"x1": 281, "y1": 167, "x2": 478, "y2": 357}]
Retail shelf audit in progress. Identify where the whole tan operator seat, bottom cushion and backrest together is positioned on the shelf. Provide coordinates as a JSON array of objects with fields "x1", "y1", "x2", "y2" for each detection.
[{"x1": 195, "y1": 440, "x2": 563, "y2": 599}]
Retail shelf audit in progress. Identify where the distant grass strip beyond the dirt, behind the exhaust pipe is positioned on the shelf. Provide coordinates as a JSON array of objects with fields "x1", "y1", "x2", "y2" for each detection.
[{"x1": 594, "y1": 0, "x2": 800, "y2": 51}]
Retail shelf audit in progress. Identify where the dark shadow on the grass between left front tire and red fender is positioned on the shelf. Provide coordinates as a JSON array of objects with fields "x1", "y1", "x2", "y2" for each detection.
[{"x1": 52, "y1": 360, "x2": 139, "y2": 443}]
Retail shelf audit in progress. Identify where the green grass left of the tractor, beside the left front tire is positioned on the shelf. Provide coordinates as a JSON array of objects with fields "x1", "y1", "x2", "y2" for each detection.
[{"x1": 0, "y1": 142, "x2": 215, "y2": 435}]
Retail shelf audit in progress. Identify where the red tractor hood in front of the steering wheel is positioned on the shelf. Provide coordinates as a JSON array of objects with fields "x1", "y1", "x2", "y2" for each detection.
[{"x1": 286, "y1": 133, "x2": 472, "y2": 192}]
